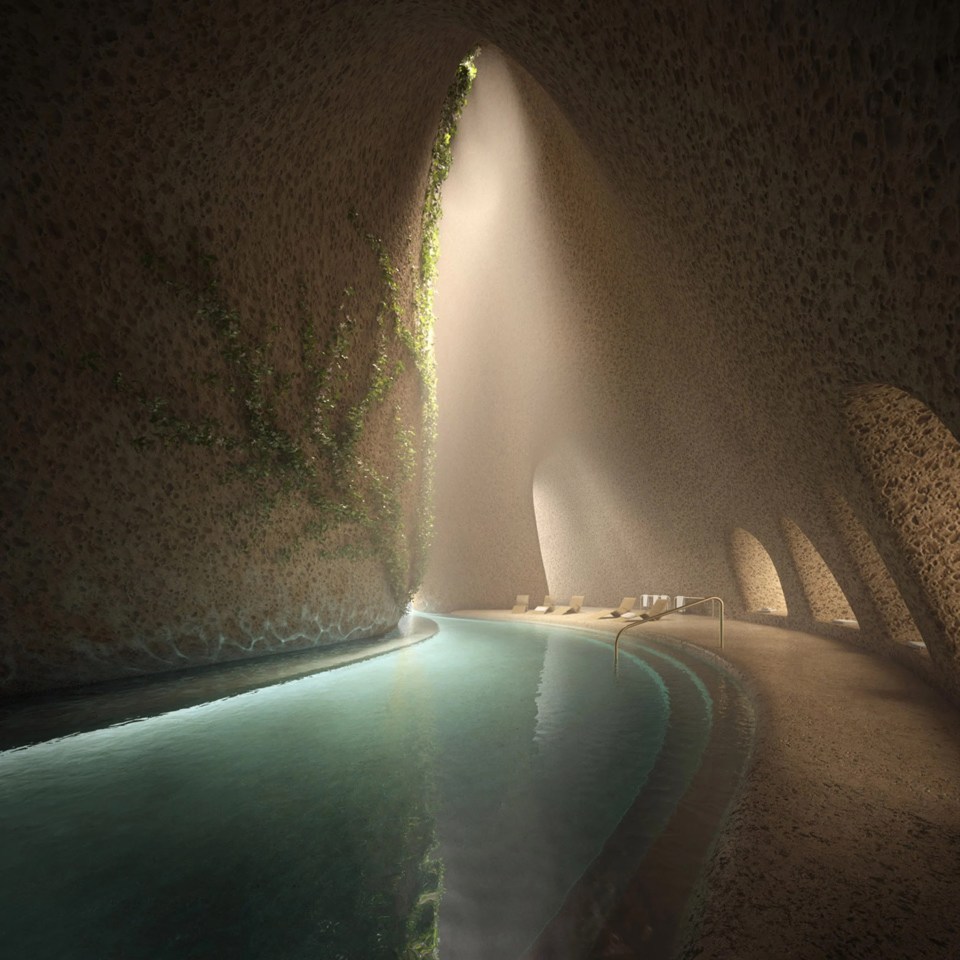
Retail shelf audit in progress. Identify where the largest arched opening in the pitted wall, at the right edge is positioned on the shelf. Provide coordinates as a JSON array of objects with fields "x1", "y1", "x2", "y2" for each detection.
[{"x1": 846, "y1": 384, "x2": 960, "y2": 657}]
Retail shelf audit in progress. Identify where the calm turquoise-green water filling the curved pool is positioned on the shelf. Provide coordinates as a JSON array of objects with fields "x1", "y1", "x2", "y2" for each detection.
[{"x1": 0, "y1": 619, "x2": 712, "y2": 960}]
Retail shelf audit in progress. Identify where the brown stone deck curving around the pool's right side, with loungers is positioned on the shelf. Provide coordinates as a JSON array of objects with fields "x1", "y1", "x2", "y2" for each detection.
[{"x1": 456, "y1": 609, "x2": 960, "y2": 960}]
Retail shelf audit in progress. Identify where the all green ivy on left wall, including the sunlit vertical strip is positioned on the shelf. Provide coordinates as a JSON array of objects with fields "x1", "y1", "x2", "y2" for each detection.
[{"x1": 110, "y1": 54, "x2": 476, "y2": 607}]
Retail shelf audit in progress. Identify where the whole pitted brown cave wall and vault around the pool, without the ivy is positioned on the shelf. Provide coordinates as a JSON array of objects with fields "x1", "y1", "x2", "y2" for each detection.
[{"x1": 0, "y1": 0, "x2": 960, "y2": 689}]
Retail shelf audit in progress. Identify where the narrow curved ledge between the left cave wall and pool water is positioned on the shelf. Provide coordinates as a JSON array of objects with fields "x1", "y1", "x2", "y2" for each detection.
[{"x1": 0, "y1": 613, "x2": 440, "y2": 752}]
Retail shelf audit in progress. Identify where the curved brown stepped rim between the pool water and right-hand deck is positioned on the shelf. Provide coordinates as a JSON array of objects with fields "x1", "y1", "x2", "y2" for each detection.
[{"x1": 449, "y1": 610, "x2": 764, "y2": 960}]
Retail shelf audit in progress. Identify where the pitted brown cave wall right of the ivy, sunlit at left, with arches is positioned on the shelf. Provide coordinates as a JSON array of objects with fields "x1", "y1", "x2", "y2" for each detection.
[{"x1": 424, "y1": 4, "x2": 960, "y2": 694}]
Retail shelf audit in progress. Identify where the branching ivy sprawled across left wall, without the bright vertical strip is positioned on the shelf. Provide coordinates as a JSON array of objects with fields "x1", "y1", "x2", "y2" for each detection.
[{"x1": 123, "y1": 254, "x2": 386, "y2": 562}]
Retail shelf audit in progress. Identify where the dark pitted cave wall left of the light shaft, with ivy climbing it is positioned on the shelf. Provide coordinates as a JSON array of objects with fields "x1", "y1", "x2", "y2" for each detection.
[{"x1": 0, "y1": 3, "x2": 478, "y2": 693}]
